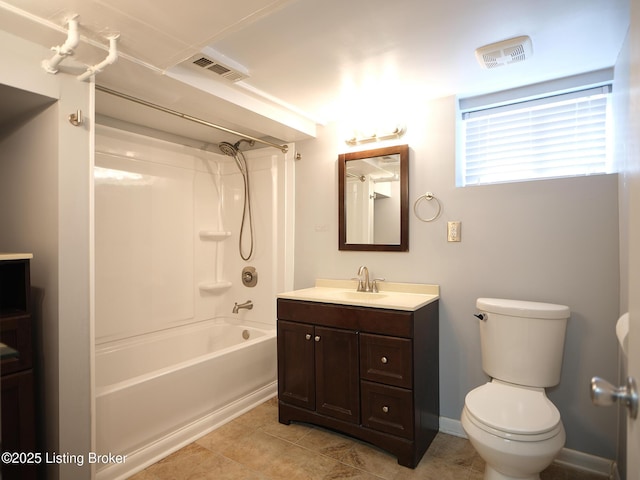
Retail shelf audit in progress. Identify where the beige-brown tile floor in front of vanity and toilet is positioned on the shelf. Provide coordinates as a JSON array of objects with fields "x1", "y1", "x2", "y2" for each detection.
[{"x1": 131, "y1": 398, "x2": 606, "y2": 480}]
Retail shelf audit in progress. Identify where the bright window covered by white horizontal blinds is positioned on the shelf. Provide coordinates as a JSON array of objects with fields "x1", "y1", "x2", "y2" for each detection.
[{"x1": 457, "y1": 85, "x2": 611, "y2": 186}]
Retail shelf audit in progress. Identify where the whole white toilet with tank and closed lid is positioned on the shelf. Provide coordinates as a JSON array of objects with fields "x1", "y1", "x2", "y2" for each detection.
[{"x1": 461, "y1": 298, "x2": 570, "y2": 480}]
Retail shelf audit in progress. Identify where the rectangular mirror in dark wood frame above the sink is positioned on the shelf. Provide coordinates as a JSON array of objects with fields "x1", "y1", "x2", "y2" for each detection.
[{"x1": 338, "y1": 145, "x2": 409, "y2": 252}]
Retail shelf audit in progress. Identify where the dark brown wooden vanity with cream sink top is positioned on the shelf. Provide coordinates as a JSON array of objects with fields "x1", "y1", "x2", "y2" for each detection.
[{"x1": 277, "y1": 280, "x2": 440, "y2": 468}]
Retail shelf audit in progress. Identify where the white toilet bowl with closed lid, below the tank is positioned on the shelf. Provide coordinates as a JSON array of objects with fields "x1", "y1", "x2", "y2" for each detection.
[{"x1": 461, "y1": 380, "x2": 566, "y2": 480}]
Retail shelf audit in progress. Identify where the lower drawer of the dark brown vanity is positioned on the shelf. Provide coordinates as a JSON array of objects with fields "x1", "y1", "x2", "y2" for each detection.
[{"x1": 360, "y1": 381, "x2": 413, "y2": 439}]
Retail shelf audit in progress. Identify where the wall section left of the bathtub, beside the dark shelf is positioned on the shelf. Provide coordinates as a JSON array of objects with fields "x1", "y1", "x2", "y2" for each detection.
[{"x1": 0, "y1": 31, "x2": 93, "y2": 480}]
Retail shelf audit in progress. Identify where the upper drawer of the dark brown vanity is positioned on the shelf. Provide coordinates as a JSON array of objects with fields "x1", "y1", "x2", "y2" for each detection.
[{"x1": 360, "y1": 333, "x2": 413, "y2": 388}]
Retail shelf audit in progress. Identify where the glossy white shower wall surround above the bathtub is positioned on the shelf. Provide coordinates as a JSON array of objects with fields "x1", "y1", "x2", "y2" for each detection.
[{"x1": 94, "y1": 126, "x2": 292, "y2": 344}]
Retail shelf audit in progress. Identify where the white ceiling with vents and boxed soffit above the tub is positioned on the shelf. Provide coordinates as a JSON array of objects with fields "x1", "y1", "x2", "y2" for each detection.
[{"x1": 0, "y1": 0, "x2": 629, "y2": 146}]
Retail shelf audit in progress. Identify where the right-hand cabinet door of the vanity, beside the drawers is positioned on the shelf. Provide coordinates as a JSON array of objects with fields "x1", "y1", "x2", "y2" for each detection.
[{"x1": 314, "y1": 327, "x2": 360, "y2": 423}]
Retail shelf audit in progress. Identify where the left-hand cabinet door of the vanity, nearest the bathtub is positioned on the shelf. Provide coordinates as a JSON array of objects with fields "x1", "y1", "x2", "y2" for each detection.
[{"x1": 278, "y1": 320, "x2": 316, "y2": 410}]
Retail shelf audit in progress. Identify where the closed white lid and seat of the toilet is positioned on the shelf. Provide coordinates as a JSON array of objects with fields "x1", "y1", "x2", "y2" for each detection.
[{"x1": 465, "y1": 380, "x2": 560, "y2": 435}]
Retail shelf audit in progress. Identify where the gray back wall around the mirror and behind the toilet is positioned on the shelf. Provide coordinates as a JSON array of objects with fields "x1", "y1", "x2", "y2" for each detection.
[{"x1": 295, "y1": 97, "x2": 619, "y2": 459}]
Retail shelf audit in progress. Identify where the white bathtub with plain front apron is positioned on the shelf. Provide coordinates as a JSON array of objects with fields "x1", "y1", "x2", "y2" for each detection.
[{"x1": 95, "y1": 319, "x2": 277, "y2": 480}]
